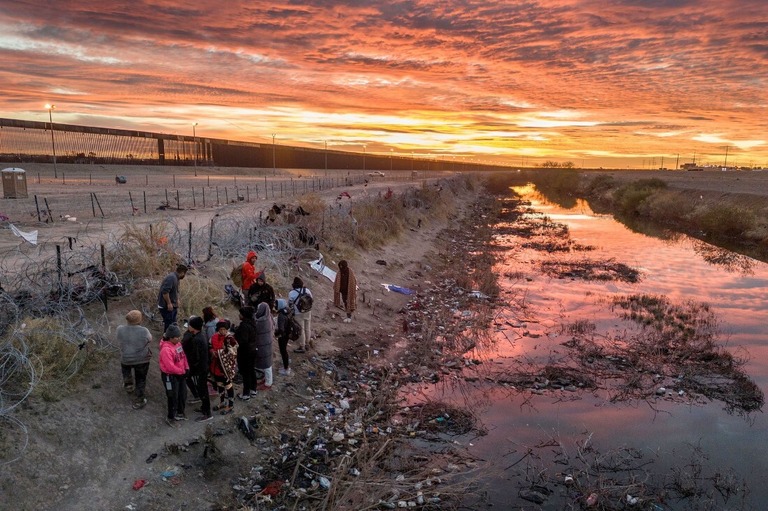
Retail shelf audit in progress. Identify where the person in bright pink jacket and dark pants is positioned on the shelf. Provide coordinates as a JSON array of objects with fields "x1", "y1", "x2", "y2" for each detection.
[{"x1": 159, "y1": 325, "x2": 189, "y2": 427}]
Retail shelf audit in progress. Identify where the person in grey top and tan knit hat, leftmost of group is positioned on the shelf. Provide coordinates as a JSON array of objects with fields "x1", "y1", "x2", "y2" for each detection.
[{"x1": 117, "y1": 310, "x2": 152, "y2": 410}]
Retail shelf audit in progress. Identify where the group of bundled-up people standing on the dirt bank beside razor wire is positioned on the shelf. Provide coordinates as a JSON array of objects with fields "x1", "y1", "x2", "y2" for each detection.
[{"x1": 116, "y1": 251, "x2": 356, "y2": 426}]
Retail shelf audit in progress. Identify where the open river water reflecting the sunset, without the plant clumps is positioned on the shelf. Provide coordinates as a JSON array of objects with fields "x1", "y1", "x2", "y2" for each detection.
[{"x1": 419, "y1": 188, "x2": 768, "y2": 509}]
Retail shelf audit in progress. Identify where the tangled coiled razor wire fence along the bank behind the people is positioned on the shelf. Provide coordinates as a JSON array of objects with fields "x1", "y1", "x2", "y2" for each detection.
[{"x1": 0, "y1": 173, "x2": 456, "y2": 452}]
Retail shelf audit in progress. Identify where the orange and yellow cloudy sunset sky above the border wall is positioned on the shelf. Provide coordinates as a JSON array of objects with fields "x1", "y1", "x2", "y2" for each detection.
[{"x1": 0, "y1": 0, "x2": 768, "y2": 168}]
